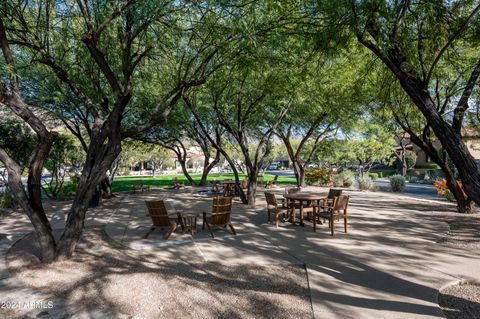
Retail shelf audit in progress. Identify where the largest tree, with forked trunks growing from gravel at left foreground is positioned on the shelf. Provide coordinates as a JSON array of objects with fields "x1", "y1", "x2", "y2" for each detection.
[{"x1": 0, "y1": 0, "x2": 239, "y2": 262}]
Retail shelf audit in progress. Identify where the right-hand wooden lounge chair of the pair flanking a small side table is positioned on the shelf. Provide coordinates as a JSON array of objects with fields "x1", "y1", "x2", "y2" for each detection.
[{"x1": 202, "y1": 197, "x2": 237, "y2": 238}]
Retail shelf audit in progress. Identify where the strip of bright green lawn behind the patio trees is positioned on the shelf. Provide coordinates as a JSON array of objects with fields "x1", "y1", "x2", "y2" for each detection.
[{"x1": 112, "y1": 173, "x2": 296, "y2": 192}]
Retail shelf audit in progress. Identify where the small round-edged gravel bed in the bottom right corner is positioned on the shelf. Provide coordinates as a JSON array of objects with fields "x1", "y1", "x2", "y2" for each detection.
[{"x1": 438, "y1": 283, "x2": 480, "y2": 319}]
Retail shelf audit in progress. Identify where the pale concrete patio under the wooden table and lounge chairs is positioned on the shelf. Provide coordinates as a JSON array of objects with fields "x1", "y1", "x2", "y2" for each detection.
[{"x1": 0, "y1": 188, "x2": 480, "y2": 318}]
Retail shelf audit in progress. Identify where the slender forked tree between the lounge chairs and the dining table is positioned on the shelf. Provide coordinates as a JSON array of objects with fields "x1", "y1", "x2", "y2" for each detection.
[{"x1": 209, "y1": 61, "x2": 289, "y2": 206}]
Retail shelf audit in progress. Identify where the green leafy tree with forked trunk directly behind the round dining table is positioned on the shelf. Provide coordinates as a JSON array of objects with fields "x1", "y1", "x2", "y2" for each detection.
[{"x1": 277, "y1": 55, "x2": 362, "y2": 187}]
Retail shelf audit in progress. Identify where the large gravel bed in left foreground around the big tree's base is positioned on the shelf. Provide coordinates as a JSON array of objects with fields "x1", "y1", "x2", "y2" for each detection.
[{"x1": 7, "y1": 228, "x2": 313, "y2": 318}]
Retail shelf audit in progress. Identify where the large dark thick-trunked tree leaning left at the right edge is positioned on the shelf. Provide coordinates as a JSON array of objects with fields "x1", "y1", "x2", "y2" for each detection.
[{"x1": 334, "y1": 0, "x2": 480, "y2": 210}]
